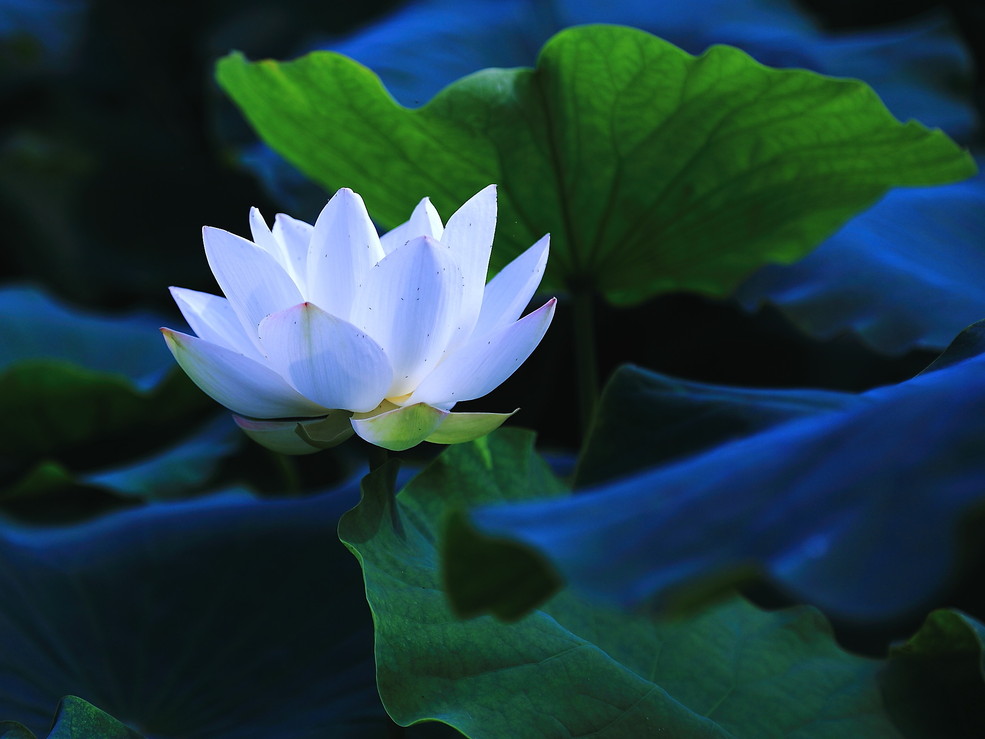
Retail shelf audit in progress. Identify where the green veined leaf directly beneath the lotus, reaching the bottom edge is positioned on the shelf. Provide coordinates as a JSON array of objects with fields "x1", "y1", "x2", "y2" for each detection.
[{"x1": 339, "y1": 429, "x2": 897, "y2": 739}]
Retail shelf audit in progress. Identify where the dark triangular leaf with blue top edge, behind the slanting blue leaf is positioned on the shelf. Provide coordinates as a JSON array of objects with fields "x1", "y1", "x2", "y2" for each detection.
[{"x1": 575, "y1": 365, "x2": 855, "y2": 487}]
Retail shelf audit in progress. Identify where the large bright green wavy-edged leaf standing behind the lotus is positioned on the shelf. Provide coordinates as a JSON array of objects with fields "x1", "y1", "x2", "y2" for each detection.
[{"x1": 217, "y1": 26, "x2": 975, "y2": 302}]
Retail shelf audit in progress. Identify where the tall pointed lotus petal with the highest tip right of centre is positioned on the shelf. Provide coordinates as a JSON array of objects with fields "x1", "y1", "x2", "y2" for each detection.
[{"x1": 441, "y1": 185, "x2": 496, "y2": 350}]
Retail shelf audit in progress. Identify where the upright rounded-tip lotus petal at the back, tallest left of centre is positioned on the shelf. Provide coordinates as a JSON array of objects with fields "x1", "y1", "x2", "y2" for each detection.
[{"x1": 307, "y1": 188, "x2": 385, "y2": 320}]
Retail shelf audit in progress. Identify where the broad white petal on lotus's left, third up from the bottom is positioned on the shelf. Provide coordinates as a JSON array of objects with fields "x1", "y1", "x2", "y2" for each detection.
[{"x1": 202, "y1": 227, "x2": 302, "y2": 342}]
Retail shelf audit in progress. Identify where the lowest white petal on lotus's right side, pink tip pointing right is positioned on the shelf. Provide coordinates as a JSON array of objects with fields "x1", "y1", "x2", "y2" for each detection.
[{"x1": 407, "y1": 298, "x2": 557, "y2": 405}]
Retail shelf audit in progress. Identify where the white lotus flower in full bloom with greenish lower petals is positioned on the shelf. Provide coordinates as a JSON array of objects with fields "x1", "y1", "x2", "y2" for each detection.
[{"x1": 161, "y1": 186, "x2": 555, "y2": 454}]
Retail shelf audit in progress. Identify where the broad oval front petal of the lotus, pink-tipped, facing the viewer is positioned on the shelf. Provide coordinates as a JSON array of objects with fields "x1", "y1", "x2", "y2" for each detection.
[{"x1": 260, "y1": 303, "x2": 393, "y2": 411}]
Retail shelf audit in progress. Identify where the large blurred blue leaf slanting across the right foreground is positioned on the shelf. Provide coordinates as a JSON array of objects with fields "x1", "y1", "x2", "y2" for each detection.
[{"x1": 447, "y1": 336, "x2": 985, "y2": 623}]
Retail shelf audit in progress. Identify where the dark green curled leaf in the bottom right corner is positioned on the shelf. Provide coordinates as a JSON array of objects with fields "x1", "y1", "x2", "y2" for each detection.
[{"x1": 880, "y1": 610, "x2": 985, "y2": 739}]
